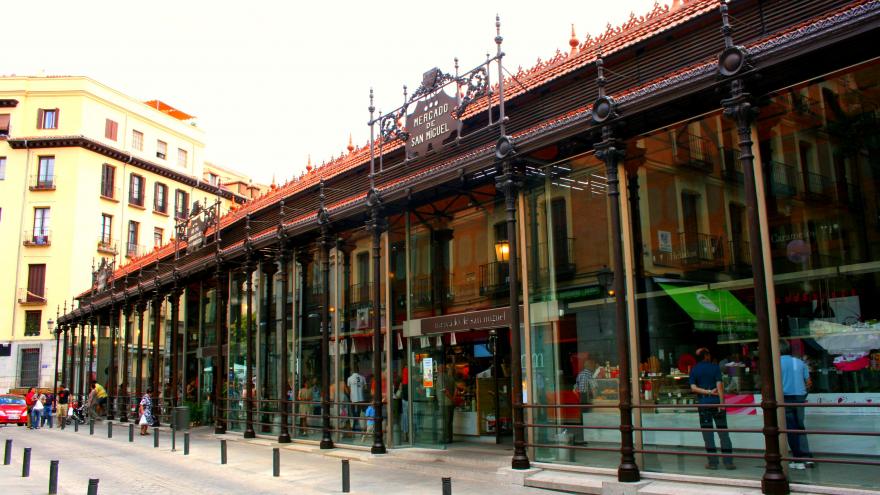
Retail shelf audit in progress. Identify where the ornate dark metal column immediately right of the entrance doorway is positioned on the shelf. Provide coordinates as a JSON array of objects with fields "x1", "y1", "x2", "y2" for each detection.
[{"x1": 495, "y1": 134, "x2": 530, "y2": 469}]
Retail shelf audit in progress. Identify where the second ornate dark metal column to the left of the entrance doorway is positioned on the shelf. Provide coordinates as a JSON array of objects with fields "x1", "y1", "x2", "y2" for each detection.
[{"x1": 317, "y1": 189, "x2": 335, "y2": 449}]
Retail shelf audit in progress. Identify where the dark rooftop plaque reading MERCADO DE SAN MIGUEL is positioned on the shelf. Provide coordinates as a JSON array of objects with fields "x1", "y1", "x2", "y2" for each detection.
[{"x1": 405, "y1": 68, "x2": 460, "y2": 158}]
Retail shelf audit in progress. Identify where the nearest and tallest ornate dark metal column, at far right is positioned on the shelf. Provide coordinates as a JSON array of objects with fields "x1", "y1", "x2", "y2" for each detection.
[{"x1": 718, "y1": 2, "x2": 790, "y2": 495}]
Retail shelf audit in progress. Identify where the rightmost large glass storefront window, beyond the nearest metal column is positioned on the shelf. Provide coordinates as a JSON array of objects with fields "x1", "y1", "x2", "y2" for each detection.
[{"x1": 757, "y1": 62, "x2": 880, "y2": 486}]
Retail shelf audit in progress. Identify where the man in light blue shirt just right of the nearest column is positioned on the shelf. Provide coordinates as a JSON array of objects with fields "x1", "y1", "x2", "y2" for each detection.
[{"x1": 779, "y1": 340, "x2": 815, "y2": 469}]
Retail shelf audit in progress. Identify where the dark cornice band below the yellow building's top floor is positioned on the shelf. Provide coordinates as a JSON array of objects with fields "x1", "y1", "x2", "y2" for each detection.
[{"x1": 7, "y1": 136, "x2": 247, "y2": 204}]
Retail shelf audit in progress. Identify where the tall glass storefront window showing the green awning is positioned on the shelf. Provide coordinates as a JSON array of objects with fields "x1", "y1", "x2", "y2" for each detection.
[{"x1": 621, "y1": 112, "x2": 768, "y2": 477}]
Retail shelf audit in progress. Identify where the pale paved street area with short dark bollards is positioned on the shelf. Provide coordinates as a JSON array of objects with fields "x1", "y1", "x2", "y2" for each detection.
[{"x1": 0, "y1": 422, "x2": 551, "y2": 495}]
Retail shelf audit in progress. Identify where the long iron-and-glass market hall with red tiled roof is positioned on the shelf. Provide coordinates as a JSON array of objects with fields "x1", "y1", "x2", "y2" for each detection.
[{"x1": 58, "y1": 0, "x2": 880, "y2": 493}]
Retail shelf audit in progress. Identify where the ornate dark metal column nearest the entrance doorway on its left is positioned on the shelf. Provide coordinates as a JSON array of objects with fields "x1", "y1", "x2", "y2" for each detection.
[{"x1": 367, "y1": 187, "x2": 386, "y2": 454}]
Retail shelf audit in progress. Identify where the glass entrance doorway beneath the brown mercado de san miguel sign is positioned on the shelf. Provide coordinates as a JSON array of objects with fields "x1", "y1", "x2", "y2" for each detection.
[{"x1": 402, "y1": 328, "x2": 512, "y2": 448}]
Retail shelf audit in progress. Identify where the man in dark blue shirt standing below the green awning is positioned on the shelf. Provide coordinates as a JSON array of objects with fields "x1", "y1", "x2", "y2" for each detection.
[{"x1": 690, "y1": 347, "x2": 736, "y2": 469}]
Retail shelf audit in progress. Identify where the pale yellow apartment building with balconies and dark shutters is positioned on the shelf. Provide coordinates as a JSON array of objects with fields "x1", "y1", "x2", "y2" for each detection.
[{"x1": 0, "y1": 76, "x2": 254, "y2": 392}]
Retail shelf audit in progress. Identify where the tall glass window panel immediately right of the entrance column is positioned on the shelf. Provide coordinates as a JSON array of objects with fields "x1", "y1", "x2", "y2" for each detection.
[{"x1": 523, "y1": 148, "x2": 622, "y2": 467}]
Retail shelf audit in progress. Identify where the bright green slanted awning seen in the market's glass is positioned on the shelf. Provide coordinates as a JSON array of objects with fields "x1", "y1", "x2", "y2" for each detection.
[{"x1": 659, "y1": 283, "x2": 756, "y2": 332}]
